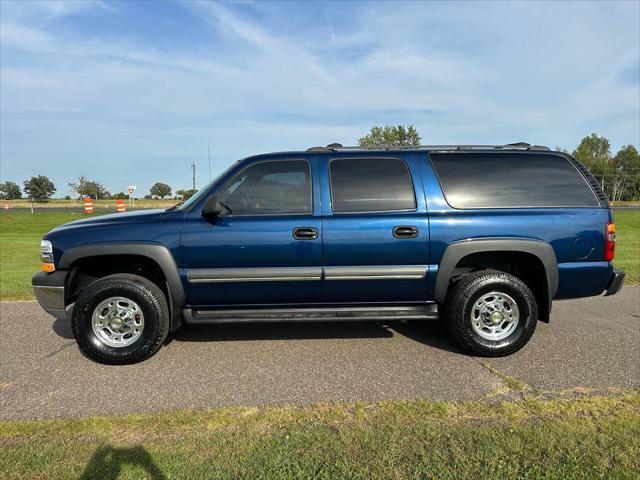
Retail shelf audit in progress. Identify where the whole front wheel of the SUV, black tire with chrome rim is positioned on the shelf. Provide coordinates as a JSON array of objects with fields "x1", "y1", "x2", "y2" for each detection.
[{"x1": 71, "y1": 274, "x2": 169, "y2": 365}]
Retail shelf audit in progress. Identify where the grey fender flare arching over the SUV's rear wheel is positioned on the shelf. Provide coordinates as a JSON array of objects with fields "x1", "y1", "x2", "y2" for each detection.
[{"x1": 434, "y1": 238, "x2": 558, "y2": 307}]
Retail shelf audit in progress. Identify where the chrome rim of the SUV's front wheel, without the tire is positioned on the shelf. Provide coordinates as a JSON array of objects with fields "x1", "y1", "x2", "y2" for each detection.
[{"x1": 91, "y1": 297, "x2": 144, "y2": 348}]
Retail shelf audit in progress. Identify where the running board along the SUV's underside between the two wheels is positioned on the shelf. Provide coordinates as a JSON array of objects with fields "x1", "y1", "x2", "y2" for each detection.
[{"x1": 182, "y1": 303, "x2": 438, "y2": 324}]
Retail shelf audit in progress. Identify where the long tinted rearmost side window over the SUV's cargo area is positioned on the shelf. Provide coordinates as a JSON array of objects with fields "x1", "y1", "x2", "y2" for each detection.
[{"x1": 429, "y1": 153, "x2": 600, "y2": 209}]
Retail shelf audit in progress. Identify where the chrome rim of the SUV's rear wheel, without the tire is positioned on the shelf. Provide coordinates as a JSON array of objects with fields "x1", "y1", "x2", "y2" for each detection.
[{"x1": 471, "y1": 292, "x2": 520, "y2": 341}]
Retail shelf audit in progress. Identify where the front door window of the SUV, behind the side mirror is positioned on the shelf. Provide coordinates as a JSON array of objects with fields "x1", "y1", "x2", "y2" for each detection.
[{"x1": 217, "y1": 160, "x2": 313, "y2": 215}]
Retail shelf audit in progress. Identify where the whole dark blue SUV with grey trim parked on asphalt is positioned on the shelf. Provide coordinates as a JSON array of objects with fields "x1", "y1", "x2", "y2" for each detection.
[{"x1": 32, "y1": 143, "x2": 624, "y2": 364}]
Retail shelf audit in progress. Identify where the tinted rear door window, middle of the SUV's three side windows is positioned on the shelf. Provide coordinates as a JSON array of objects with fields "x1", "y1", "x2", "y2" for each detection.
[{"x1": 329, "y1": 158, "x2": 416, "y2": 213}]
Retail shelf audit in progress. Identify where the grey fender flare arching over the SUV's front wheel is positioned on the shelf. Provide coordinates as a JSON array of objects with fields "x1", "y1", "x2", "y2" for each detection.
[{"x1": 59, "y1": 243, "x2": 185, "y2": 332}]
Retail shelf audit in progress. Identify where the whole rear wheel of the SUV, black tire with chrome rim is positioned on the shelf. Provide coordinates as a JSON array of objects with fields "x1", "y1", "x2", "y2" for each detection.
[{"x1": 444, "y1": 271, "x2": 538, "y2": 357}]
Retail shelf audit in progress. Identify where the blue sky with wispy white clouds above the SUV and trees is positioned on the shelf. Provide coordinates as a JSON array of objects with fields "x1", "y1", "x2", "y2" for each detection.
[{"x1": 0, "y1": 0, "x2": 640, "y2": 196}]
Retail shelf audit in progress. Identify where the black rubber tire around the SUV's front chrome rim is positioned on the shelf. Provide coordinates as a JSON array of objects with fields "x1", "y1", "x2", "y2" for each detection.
[{"x1": 71, "y1": 274, "x2": 169, "y2": 365}]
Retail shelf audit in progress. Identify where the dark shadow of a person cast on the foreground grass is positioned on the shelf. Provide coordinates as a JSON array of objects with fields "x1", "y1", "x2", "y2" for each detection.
[{"x1": 79, "y1": 444, "x2": 167, "y2": 480}]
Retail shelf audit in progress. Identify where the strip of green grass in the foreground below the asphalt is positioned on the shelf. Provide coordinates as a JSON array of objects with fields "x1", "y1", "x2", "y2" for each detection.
[{"x1": 0, "y1": 392, "x2": 640, "y2": 480}]
